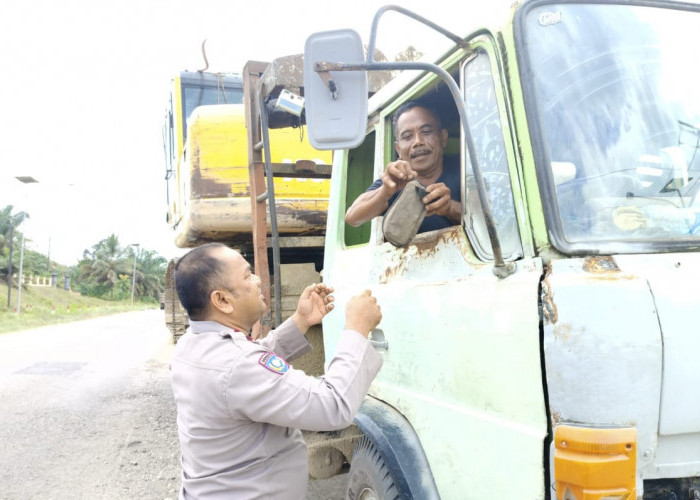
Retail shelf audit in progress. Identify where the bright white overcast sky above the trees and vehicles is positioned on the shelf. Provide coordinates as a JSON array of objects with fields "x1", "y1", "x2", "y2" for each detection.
[{"x1": 0, "y1": 0, "x2": 509, "y2": 265}]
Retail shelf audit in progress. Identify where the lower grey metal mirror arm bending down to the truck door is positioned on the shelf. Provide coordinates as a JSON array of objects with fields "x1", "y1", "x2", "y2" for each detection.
[{"x1": 314, "y1": 61, "x2": 515, "y2": 279}]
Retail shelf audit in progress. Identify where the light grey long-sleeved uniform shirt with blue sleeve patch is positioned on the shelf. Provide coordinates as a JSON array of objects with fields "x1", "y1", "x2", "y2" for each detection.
[{"x1": 171, "y1": 319, "x2": 382, "y2": 500}]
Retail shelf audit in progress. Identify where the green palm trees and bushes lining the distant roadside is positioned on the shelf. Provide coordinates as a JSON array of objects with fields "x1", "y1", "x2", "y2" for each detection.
[{"x1": 0, "y1": 205, "x2": 167, "y2": 301}]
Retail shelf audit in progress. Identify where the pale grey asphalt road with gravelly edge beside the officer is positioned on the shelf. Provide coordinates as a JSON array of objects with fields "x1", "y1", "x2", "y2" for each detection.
[{"x1": 0, "y1": 309, "x2": 346, "y2": 500}]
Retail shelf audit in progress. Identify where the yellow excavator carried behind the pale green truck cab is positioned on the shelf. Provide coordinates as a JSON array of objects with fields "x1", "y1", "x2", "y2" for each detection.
[{"x1": 163, "y1": 63, "x2": 332, "y2": 341}]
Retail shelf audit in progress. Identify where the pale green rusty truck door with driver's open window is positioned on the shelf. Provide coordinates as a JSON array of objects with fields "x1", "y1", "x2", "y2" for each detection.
[{"x1": 324, "y1": 37, "x2": 547, "y2": 498}]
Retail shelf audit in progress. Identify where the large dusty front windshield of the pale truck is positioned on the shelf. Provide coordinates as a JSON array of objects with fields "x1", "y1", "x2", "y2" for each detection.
[{"x1": 521, "y1": 3, "x2": 700, "y2": 252}]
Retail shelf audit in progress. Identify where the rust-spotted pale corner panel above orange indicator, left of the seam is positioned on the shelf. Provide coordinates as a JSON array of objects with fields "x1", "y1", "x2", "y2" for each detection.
[{"x1": 542, "y1": 257, "x2": 662, "y2": 434}]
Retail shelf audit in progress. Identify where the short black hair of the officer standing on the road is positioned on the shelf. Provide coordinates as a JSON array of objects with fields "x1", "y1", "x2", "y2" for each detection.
[{"x1": 175, "y1": 243, "x2": 226, "y2": 321}]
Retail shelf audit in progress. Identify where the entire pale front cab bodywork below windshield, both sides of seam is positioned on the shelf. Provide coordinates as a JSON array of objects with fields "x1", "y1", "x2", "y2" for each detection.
[{"x1": 542, "y1": 253, "x2": 700, "y2": 484}]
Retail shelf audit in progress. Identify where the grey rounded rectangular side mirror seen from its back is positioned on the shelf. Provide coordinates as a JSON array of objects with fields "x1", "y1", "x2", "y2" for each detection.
[{"x1": 304, "y1": 29, "x2": 367, "y2": 149}]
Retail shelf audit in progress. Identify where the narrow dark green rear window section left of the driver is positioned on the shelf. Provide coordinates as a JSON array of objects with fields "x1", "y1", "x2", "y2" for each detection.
[{"x1": 343, "y1": 132, "x2": 375, "y2": 246}]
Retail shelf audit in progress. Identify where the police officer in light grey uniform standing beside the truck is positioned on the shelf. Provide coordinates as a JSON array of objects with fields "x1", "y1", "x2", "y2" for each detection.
[{"x1": 171, "y1": 243, "x2": 382, "y2": 499}]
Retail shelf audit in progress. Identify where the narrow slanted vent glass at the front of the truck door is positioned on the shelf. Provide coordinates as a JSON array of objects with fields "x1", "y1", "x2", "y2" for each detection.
[{"x1": 462, "y1": 49, "x2": 522, "y2": 260}]
